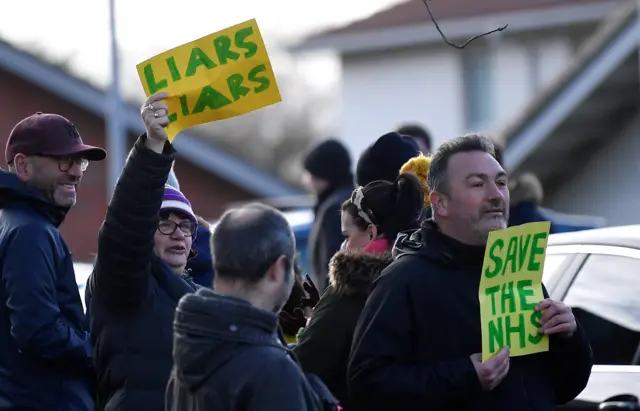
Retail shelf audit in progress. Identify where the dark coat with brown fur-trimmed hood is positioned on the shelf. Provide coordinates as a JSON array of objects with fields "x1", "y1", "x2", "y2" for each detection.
[{"x1": 293, "y1": 250, "x2": 392, "y2": 410}]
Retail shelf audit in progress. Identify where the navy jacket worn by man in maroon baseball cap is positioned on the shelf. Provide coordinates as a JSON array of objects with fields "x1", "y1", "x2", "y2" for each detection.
[{"x1": 0, "y1": 171, "x2": 95, "y2": 411}]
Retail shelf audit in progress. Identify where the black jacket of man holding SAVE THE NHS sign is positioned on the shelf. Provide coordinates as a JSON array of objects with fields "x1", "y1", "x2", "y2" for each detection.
[{"x1": 349, "y1": 222, "x2": 593, "y2": 411}]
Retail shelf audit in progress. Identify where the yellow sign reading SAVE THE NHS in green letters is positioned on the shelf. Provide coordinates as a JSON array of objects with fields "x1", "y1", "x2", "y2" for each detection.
[{"x1": 478, "y1": 221, "x2": 551, "y2": 361}]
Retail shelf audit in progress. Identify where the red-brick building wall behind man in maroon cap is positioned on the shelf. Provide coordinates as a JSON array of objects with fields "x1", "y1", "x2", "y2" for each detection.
[{"x1": 0, "y1": 70, "x2": 253, "y2": 261}]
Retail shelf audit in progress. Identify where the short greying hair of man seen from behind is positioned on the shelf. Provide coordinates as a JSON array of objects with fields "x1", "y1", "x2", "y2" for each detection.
[{"x1": 211, "y1": 203, "x2": 296, "y2": 285}]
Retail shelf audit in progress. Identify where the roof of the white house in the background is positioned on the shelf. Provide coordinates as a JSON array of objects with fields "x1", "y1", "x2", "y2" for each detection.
[{"x1": 291, "y1": 0, "x2": 618, "y2": 53}]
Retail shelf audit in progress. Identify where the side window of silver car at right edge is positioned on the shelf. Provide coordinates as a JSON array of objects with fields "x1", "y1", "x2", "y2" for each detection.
[{"x1": 565, "y1": 254, "x2": 640, "y2": 365}]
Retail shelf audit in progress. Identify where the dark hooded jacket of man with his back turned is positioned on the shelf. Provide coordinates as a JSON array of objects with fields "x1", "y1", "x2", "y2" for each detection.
[{"x1": 167, "y1": 289, "x2": 335, "y2": 411}]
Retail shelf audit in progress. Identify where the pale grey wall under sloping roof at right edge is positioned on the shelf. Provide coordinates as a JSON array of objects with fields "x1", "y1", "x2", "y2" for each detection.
[{"x1": 546, "y1": 115, "x2": 640, "y2": 226}]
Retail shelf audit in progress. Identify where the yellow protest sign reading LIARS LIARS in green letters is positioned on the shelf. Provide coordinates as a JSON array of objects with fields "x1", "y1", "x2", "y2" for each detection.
[{"x1": 136, "y1": 19, "x2": 282, "y2": 141}]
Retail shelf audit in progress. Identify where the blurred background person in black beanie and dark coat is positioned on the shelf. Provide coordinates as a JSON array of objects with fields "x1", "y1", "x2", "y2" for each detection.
[{"x1": 303, "y1": 139, "x2": 353, "y2": 291}]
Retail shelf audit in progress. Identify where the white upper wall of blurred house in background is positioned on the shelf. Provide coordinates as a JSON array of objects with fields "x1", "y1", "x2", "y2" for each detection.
[{"x1": 339, "y1": 33, "x2": 575, "y2": 156}]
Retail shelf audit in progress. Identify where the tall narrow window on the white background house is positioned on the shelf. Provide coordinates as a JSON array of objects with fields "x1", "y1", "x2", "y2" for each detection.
[{"x1": 462, "y1": 47, "x2": 493, "y2": 131}]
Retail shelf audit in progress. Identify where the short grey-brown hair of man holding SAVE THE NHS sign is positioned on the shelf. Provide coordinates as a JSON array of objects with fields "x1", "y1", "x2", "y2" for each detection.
[{"x1": 427, "y1": 133, "x2": 496, "y2": 193}]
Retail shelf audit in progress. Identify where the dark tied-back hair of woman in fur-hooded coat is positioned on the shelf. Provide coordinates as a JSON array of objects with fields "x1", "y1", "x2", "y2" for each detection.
[{"x1": 342, "y1": 173, "x2": 424, "y2": 241}]
